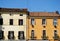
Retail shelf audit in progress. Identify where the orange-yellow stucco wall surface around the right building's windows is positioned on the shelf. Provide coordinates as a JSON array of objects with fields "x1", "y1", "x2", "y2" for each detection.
[{"x1": 27, "y1": 18, "x2": 60, "y2": 41}]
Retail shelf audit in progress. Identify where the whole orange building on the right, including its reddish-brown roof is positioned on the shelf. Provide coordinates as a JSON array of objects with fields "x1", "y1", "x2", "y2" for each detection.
[{"x1": 27, "y1": 12, "x2": 60, "y2": 41}]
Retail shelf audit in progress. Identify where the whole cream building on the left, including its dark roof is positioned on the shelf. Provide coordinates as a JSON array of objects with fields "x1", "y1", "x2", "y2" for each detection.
[{"x1": 0, "y1": 8, "x2": 27, "y2": 40}]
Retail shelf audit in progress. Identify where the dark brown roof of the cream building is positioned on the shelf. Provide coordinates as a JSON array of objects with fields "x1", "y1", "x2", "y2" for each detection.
[{"x1": 0, "y1": 8, "x2": 27, "y2": 12}]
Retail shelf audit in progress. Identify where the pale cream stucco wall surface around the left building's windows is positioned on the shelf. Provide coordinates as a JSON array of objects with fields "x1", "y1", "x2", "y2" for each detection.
[{"x1": 1, "y1": 13, "x2": 27, "y2": 39}]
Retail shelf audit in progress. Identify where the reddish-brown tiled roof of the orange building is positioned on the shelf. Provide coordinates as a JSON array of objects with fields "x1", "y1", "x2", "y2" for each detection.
[{"x1": 29, "y1": 12, "x2": 60, "y2": 17}]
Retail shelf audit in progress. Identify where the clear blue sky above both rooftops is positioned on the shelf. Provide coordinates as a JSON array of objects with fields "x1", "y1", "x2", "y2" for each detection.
[{"x1": 0, "y1": 0, "x2": 60, "y2": 12}]
